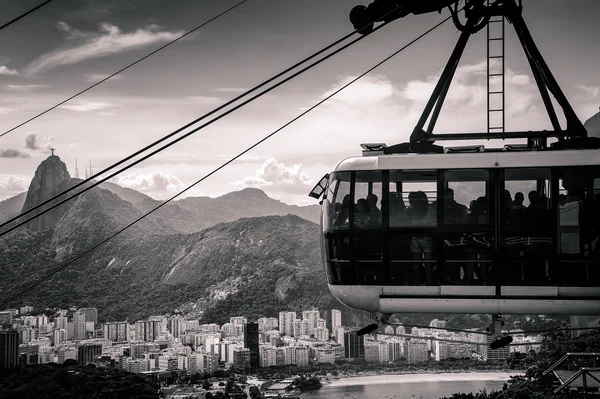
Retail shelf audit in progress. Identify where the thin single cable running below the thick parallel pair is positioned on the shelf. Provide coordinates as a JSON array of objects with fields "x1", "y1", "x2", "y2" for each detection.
[{"x1": 0, "y1": 12, "x2": 450, "y2": 308}]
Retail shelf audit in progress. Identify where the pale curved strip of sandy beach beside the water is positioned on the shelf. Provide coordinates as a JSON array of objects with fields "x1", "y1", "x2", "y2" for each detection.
[{"x1": 321, "y1": 370, "x2": 524, "y2": 389}]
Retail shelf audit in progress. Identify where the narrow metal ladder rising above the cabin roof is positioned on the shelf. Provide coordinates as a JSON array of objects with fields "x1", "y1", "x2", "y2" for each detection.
[{"x1": 487, "y1": 0, "x2": 506, "y2": 133}]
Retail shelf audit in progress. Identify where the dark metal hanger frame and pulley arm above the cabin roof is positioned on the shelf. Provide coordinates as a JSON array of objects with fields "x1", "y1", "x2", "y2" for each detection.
[{"x1": 350, "y1": 0, "x2": 597, "y2": 154}]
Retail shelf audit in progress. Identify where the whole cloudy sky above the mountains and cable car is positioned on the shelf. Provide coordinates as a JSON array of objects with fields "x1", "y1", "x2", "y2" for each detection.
[{"x1": 0, "y1": 0, "x2": 600, "y2": 204}]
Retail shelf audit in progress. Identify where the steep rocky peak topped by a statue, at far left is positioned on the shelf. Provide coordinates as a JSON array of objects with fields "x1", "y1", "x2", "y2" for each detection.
[{"x1": 23, "y1": 155, "x2": 71, "y2": 231}]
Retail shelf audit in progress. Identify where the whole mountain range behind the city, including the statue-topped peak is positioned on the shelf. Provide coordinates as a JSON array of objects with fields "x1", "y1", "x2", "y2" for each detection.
[{"x1": 0, "y1": 156, "x2": 337, "y2": 323}]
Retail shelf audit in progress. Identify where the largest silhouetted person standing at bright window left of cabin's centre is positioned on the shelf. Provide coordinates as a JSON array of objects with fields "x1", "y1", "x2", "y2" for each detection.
[{"x1": 405, "y1": 191, "x2": 437, "y2": 285}]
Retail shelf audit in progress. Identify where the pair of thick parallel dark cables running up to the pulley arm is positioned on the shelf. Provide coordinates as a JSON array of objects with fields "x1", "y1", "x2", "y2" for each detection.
[{"x1": 0, "y1": 2, "x2": 414, "y2": 237}]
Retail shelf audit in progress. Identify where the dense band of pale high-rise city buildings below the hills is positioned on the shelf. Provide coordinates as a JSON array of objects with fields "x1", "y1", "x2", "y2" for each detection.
[{"x1": 0, "y1": 306, "x2": 541, "y2": 372}]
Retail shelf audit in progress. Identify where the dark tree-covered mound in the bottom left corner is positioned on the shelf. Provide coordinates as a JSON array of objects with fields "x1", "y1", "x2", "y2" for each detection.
[{"x1": 0, "y1": 363, "x2": 160, "y2": 399}]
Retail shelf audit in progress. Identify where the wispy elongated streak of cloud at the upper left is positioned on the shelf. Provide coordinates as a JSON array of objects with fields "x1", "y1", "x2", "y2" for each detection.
[{"x1": 25, "y1": 22, "x2": 183, "y2": 75}]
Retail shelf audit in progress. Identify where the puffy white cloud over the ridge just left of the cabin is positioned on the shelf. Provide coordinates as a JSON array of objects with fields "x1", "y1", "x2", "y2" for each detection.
[{"x1": 232, "y1": 158, "x2": 314, "y2": 193}]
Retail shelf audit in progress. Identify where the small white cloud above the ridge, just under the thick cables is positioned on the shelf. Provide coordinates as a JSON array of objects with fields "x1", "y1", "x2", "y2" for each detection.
[{"x1": 112, "y1": 172, "x2": 186, "y2": 197}]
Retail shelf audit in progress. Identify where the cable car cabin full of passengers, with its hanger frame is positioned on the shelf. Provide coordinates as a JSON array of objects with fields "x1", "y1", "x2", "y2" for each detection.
[{"x1": 309, "y1": 0, "x2": 600, "y2": 340}]
